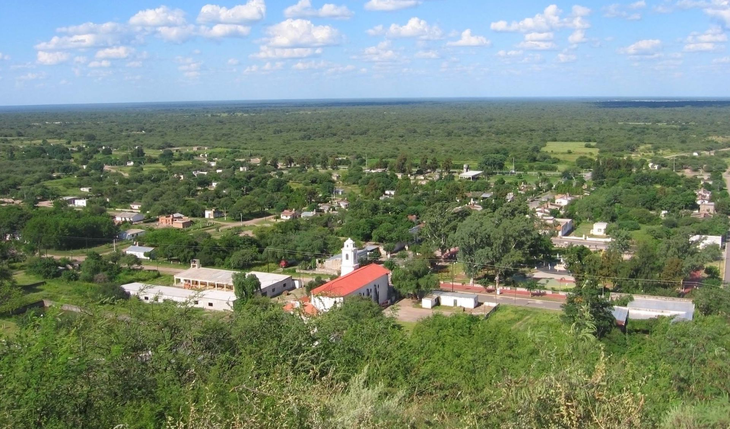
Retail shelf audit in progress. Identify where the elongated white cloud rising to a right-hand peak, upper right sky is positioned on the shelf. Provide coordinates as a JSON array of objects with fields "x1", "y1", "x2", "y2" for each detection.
[{"x1": 490, "y1": 4, "x2": 591, "y2": 33}]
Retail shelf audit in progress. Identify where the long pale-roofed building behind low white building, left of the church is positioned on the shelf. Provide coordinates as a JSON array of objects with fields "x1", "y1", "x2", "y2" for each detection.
[{"x1": 173, "y1": 259, "x2": 297, "y2": 297}]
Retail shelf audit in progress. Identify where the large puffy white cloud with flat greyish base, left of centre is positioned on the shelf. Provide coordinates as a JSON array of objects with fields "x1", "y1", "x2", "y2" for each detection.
[{"x1": 265, "y1": 19, "x2": 342, "y2": 48}]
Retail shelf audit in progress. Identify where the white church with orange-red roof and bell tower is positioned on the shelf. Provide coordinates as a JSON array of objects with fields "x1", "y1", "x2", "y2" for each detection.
[{"x1": 311, "y1": 239, "x2": 390, "y2": 311}]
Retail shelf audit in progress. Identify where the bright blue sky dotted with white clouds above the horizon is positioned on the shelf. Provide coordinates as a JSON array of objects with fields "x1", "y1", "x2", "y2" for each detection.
[{"x1": 0, "y1": 0, "x2": 730, "y2": 105}]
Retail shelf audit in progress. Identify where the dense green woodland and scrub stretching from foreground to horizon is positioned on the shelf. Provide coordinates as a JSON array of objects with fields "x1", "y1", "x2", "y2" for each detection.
[{"x1": 0, "y1": 101, "x2": 730, "y2": 428}]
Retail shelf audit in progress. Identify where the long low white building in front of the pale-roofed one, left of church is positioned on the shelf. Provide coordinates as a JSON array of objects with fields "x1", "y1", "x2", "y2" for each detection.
[{"x1": 122, "y1": 283, "x2": 236, "y2": 311}]
